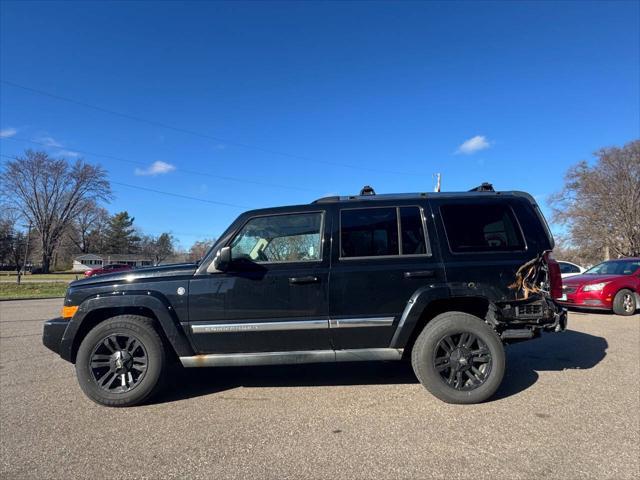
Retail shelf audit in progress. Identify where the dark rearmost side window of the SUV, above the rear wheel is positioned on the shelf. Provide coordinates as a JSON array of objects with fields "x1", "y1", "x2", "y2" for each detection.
[{"x1": 440, "y1": 203, "x2": 524, "y2": 253}]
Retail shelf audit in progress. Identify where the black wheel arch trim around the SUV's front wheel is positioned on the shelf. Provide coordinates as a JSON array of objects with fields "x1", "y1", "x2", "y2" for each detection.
[{"x1": 60, "y1": 292, "x2": 194, "y2": 363}]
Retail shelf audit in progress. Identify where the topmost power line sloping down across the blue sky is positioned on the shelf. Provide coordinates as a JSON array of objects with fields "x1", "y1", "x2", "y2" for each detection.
[{"x1": 0, "y1": 80, "x2": 420, "y2": 177}]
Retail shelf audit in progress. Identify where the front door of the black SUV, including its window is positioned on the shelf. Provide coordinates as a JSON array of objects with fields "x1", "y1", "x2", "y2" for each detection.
[{"x1": 189, "y1": 210, "x2": 330, "y2": 353}]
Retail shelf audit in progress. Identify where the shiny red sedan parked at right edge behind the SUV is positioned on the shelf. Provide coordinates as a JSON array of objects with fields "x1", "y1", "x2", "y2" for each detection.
[{"x1": 558, "y1": 258, "x2": 640, "y2": 315}]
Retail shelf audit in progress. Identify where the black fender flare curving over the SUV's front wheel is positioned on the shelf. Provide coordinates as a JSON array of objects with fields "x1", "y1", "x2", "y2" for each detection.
[{"x1": 59, "y1": 291, "x2": 195, "y2": 362}]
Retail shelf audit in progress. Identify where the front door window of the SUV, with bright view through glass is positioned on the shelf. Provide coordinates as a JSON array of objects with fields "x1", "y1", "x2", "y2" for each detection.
[{"x1": 231, "y1": 213, "x2": 322, "y2": 263}]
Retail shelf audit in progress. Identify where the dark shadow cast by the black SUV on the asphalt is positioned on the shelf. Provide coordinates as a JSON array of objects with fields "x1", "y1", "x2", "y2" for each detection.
[{"x1": 152, "y1": 331, "x2": 608, "y2": 403}]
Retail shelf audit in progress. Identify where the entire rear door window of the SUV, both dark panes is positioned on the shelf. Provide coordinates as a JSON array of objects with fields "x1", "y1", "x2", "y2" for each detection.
[{"x1": 340, "y1": 206, "x2": 430, "y2": 258}]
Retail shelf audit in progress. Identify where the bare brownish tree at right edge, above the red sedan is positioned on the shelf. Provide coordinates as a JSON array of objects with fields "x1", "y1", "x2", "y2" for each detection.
[{"x1": 550, "y1": 140, "x2": 640, "y2": 263}]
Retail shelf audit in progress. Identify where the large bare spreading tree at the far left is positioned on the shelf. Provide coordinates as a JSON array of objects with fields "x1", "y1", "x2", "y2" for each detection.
[{"x1": 0, "y1": 150, "x2": 111, "y2": 273}]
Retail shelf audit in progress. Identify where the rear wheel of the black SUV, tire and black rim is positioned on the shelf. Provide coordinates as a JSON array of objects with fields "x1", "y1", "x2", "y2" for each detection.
[{"x1": 411, "y1": 312, "x2": 505, "y2": 404}]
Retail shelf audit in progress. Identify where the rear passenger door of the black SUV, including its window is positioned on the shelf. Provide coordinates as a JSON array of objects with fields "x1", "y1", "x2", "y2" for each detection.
[{"x1": 330, "y1": 202, "x2": 444, "y2": 349}]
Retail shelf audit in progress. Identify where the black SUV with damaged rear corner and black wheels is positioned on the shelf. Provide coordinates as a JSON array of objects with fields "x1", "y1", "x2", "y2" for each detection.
[{"x1": 43, "y1": 184, "x2": 567, "y2": 406}]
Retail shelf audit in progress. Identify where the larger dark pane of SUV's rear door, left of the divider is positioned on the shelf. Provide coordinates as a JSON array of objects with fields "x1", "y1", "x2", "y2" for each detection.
[{"x1": 340, "y1": 207, "x2": 399, "y2": 257}]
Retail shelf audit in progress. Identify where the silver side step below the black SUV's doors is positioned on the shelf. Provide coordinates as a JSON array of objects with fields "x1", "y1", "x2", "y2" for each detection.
[{"x1": 180, "y1": 348, "x2": 403, "y2": 368}]
